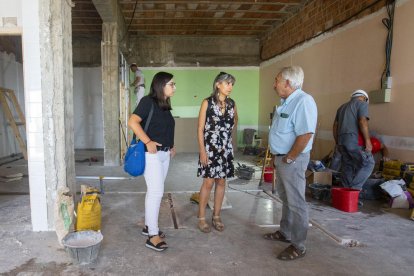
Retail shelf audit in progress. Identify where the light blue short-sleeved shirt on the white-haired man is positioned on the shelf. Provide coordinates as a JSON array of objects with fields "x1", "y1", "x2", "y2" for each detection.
[{"x1": 269, "y1": 89, "x2": 318, "y2": 154}]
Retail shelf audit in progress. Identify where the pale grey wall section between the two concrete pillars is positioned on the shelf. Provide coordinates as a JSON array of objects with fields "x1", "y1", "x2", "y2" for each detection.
[{"x1": 73, "y1": 67, "x2": 103, "y2": 149}]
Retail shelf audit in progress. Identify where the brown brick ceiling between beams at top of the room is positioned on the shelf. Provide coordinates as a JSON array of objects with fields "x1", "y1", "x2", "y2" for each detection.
[{"x1": 72, "y1": 0, "x2": 308, "y2": 37}]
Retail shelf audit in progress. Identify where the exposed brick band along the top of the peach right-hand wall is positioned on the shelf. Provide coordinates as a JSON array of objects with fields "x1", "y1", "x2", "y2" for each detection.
[{"x1": 261, "y1": 0, "x2": 386, "y2": 60}]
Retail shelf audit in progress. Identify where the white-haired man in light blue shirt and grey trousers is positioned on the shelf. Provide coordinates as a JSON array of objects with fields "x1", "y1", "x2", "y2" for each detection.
[{"x1": 264, "y1": 66, "x2": 318, "y2": 260}]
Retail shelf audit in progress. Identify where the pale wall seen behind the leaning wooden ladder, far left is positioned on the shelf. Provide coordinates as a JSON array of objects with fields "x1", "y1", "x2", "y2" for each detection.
[{"x1": 0, "y1": 52, "x2": 26, "y2": 158}]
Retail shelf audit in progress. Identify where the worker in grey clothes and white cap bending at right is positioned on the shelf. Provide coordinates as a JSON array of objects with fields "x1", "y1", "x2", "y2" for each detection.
[{"x1": 333, "y1": 90, "x2": 375, "y2": 203}]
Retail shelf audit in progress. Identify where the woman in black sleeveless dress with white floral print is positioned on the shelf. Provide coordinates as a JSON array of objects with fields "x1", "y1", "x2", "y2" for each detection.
[{"x1": 197, "y1": 72, "x2": 237, "y2": 233}]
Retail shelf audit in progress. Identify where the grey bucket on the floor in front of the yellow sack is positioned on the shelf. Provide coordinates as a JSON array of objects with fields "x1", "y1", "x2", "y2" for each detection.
[{"x1": 62, "y1": 231, "x2": 103, "y2": 265}]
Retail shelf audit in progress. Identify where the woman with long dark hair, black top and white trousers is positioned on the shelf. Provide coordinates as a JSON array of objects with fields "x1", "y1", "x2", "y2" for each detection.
[{"x1": 128, "y1": 72, "x2": 175, "y2": 251}]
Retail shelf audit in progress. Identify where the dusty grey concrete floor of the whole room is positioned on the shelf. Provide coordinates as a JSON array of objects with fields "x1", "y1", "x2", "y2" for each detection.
[{"x1": 0, "y1": 151, "x2": 414, "y2": 275}]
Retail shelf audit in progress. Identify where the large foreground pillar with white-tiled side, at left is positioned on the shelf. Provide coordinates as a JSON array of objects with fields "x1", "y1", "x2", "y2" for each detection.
[{"x1": 22, "y1": 0, "x2": 76, "y2": 231}]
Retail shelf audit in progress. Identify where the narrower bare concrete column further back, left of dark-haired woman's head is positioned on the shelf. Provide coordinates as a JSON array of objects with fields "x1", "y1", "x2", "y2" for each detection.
[{"x1": 101, "y1": 22, "x2": 120, "y2": 166}]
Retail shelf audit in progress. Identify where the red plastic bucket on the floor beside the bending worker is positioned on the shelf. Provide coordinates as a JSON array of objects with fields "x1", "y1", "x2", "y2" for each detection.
[{"x1": 331, "y1": 188, "x2": 359, "y2": 213}]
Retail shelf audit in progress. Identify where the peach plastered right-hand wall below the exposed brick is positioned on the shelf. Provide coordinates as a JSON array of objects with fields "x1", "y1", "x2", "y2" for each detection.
[{"x1": 259, "y1": 1, "x2": 414, "y2": 161}]
